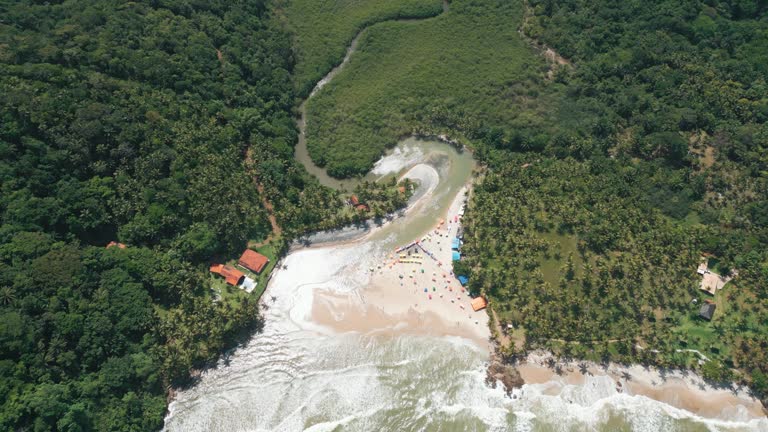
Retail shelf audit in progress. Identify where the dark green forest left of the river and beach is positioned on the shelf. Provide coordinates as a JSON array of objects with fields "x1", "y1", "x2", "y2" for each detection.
[{"x1": 0, "y1": 0, "x2": 420, "y2": 431}]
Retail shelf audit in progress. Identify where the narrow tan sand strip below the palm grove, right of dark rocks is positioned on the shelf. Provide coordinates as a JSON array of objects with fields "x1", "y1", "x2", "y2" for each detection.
[{"x1": 518, "y1": 351, "x2": 765, "y2": 420}]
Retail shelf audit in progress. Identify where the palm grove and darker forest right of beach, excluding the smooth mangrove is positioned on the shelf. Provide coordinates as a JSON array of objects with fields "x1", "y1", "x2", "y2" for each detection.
[{"x1": 465, "y1": 1, "x2": 768, "y2": 395}]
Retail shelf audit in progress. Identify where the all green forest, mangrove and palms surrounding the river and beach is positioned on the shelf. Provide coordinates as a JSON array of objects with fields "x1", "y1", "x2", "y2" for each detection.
[{"x1": 0, "y1": 0, "x2": 768, "y2": 431}]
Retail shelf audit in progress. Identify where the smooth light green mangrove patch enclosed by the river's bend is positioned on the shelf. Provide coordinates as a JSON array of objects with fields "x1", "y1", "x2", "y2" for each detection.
[{"x1": 307, "y1": 0, "x2": 545, "y2": 177}]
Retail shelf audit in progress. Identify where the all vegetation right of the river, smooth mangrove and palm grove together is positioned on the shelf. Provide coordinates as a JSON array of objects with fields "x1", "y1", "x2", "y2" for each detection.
[{"x1": 296, "y1": 0, "x2": 768, "y2": 394}]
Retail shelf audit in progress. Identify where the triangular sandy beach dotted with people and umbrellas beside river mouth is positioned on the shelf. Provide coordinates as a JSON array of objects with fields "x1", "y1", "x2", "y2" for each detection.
[{"x1": 312, "y1": 187, "x2": 490, "y2": 349}]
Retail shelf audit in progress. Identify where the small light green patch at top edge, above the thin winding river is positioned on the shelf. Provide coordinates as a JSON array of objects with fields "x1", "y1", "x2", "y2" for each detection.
[{"x1": 278, "y1": 0, "x2": 443, "y2": 97}]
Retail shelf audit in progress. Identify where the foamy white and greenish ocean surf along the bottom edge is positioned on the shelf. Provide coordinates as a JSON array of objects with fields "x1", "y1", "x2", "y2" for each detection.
[{"x1": 166, "y1": 314, "x2": 768, "y2": 432}]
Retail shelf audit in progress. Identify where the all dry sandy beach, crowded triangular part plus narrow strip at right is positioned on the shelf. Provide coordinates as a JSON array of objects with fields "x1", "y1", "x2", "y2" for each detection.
[{"x1": 302, "y1": 178, "x2": 765, "y2": 421}]
